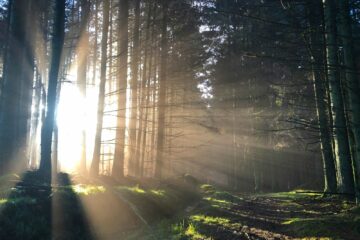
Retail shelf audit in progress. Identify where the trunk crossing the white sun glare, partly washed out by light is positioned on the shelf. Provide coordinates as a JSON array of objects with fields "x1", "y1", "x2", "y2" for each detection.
[{"x1": 77, "y1": 0, "x2": 90, "y2": 174}]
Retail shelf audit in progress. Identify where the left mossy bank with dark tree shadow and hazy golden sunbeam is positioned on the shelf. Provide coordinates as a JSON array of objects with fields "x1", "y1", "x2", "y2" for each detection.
[{"x1": 0, "y1": 172, "x2": 198, "y2": 240}]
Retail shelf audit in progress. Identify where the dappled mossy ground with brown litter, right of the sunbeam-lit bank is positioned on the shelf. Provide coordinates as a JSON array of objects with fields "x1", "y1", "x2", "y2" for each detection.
[{"x1": 129, "y1": 185, "x2": 360, "y2": 240}]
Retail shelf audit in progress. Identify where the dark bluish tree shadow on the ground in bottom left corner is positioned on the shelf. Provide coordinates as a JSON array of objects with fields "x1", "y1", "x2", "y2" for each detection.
[{"x1": 0, "y1": 172, "x2": 94, "y2": 240}]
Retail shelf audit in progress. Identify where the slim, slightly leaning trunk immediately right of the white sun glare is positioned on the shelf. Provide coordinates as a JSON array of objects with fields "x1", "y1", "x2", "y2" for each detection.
[{"x1": 90, "y1": 0, "x2": 110, "y2": 176}]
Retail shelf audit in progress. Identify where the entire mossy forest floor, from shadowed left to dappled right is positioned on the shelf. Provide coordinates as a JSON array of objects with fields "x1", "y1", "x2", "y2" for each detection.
[{"x1": 0, "y1": 172, "x2": 360, "y2": 240}]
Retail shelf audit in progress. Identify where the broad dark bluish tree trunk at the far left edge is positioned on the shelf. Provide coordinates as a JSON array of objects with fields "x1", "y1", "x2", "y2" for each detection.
[{"x1": 0, "y1": 0, "x2": 34, "y2": 173}]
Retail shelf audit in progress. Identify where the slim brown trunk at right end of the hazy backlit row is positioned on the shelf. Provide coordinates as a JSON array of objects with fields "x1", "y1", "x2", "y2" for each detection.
[{"x1": 155, "y1": 0, "x2": 168, "y2": 179}]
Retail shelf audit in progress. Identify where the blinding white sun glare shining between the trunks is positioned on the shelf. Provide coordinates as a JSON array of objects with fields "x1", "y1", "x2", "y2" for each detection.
[{"x1": 57, "y1": 71, "x2": 97, "y2": 172}]
